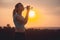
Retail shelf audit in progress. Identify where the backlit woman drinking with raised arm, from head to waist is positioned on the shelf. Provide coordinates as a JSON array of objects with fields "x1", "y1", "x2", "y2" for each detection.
[{"x1": 13, "y1": 3, "x2": 30, "y2": 32}]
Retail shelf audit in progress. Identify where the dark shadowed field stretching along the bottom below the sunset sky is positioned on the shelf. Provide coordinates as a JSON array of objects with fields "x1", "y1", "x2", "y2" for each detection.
[{"x1": 0, "y1": 27, "x2": 60, "y2": 40}]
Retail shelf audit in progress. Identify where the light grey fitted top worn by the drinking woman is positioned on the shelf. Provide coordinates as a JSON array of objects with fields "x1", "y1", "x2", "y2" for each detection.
[{"x1": 13, "y1": 13, "x2": 25, "y2": 30}]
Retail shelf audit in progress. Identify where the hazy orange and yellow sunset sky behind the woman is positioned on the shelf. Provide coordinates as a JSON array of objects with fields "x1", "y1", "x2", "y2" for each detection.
[{"x1": 0, "y1": 0, "x2": 60, "y2": 28}]
